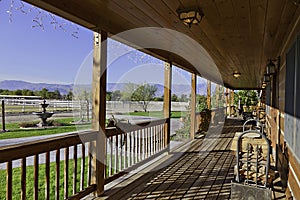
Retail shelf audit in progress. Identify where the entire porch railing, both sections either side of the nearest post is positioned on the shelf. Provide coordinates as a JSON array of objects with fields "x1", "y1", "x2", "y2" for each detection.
[{"x1": 0, "y1": 119, "x2": 166, "y2": 200}]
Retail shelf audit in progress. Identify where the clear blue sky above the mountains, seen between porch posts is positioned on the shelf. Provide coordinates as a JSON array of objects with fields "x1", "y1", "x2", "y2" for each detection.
[{"x1": 0, "y1": 0, "x2": 199, "y2": 84}]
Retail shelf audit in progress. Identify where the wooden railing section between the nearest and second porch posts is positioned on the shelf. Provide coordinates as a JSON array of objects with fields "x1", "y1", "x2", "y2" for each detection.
[{"x1": 106, "y1": 119, "x2": 166, "y2": 182}]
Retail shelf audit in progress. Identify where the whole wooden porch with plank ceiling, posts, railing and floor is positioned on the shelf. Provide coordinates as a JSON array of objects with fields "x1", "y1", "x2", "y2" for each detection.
[{"x1": 0, "y1": 0, "x2": 300, "y2": 199}]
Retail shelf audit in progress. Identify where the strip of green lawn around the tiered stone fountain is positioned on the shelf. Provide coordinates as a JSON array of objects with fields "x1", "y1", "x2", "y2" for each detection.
[{"x1": 0, "y1": 118, "x2": 91, "y2": 139}]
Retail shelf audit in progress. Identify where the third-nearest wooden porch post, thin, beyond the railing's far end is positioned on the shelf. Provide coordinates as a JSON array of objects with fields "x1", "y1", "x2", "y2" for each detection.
[{"x1": 190, "y1": 73, "x2": 197, "y2": 139}]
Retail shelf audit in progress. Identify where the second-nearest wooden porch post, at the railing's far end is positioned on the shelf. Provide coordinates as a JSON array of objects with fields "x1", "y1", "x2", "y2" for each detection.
[{"x1": 164, "y1": 62, "x2": 172, "y2": 150}]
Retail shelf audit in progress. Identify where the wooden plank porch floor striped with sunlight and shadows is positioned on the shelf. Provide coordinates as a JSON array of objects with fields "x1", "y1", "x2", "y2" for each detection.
[{"x1": 96, "y1": 119, "x2": 284, "y2": 199}]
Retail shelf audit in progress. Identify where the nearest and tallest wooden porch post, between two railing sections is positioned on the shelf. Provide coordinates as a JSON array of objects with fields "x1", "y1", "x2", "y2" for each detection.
[{"x1": 92, "y1": 31, "x2": 107, "y2": 196}]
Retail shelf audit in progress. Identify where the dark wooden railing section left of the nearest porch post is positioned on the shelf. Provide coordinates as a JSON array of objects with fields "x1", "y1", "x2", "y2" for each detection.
[{"x1": 0, "y1": 131, "x2": 96, "y2": 200}]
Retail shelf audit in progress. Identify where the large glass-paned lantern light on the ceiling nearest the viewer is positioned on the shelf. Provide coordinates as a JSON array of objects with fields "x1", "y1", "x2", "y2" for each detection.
[{"x1": 176, "y1": 7, "x2": 204, "y2": 28}]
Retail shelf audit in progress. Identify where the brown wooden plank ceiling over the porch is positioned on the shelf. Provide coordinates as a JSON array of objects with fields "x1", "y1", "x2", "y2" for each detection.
[{"x1": 25, "y1": 0, "x2": 300, "y2": 89}]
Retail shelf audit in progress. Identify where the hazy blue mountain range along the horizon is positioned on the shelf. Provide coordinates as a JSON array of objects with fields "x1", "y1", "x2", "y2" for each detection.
[{"x1": 0, "y1": 80, "x2": 206, "y2": 96}]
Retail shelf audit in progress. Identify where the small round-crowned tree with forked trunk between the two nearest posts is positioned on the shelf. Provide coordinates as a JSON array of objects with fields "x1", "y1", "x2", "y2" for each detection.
[{"x1": 131, "y1": 83, "x2": 157, "y2": 112}]
